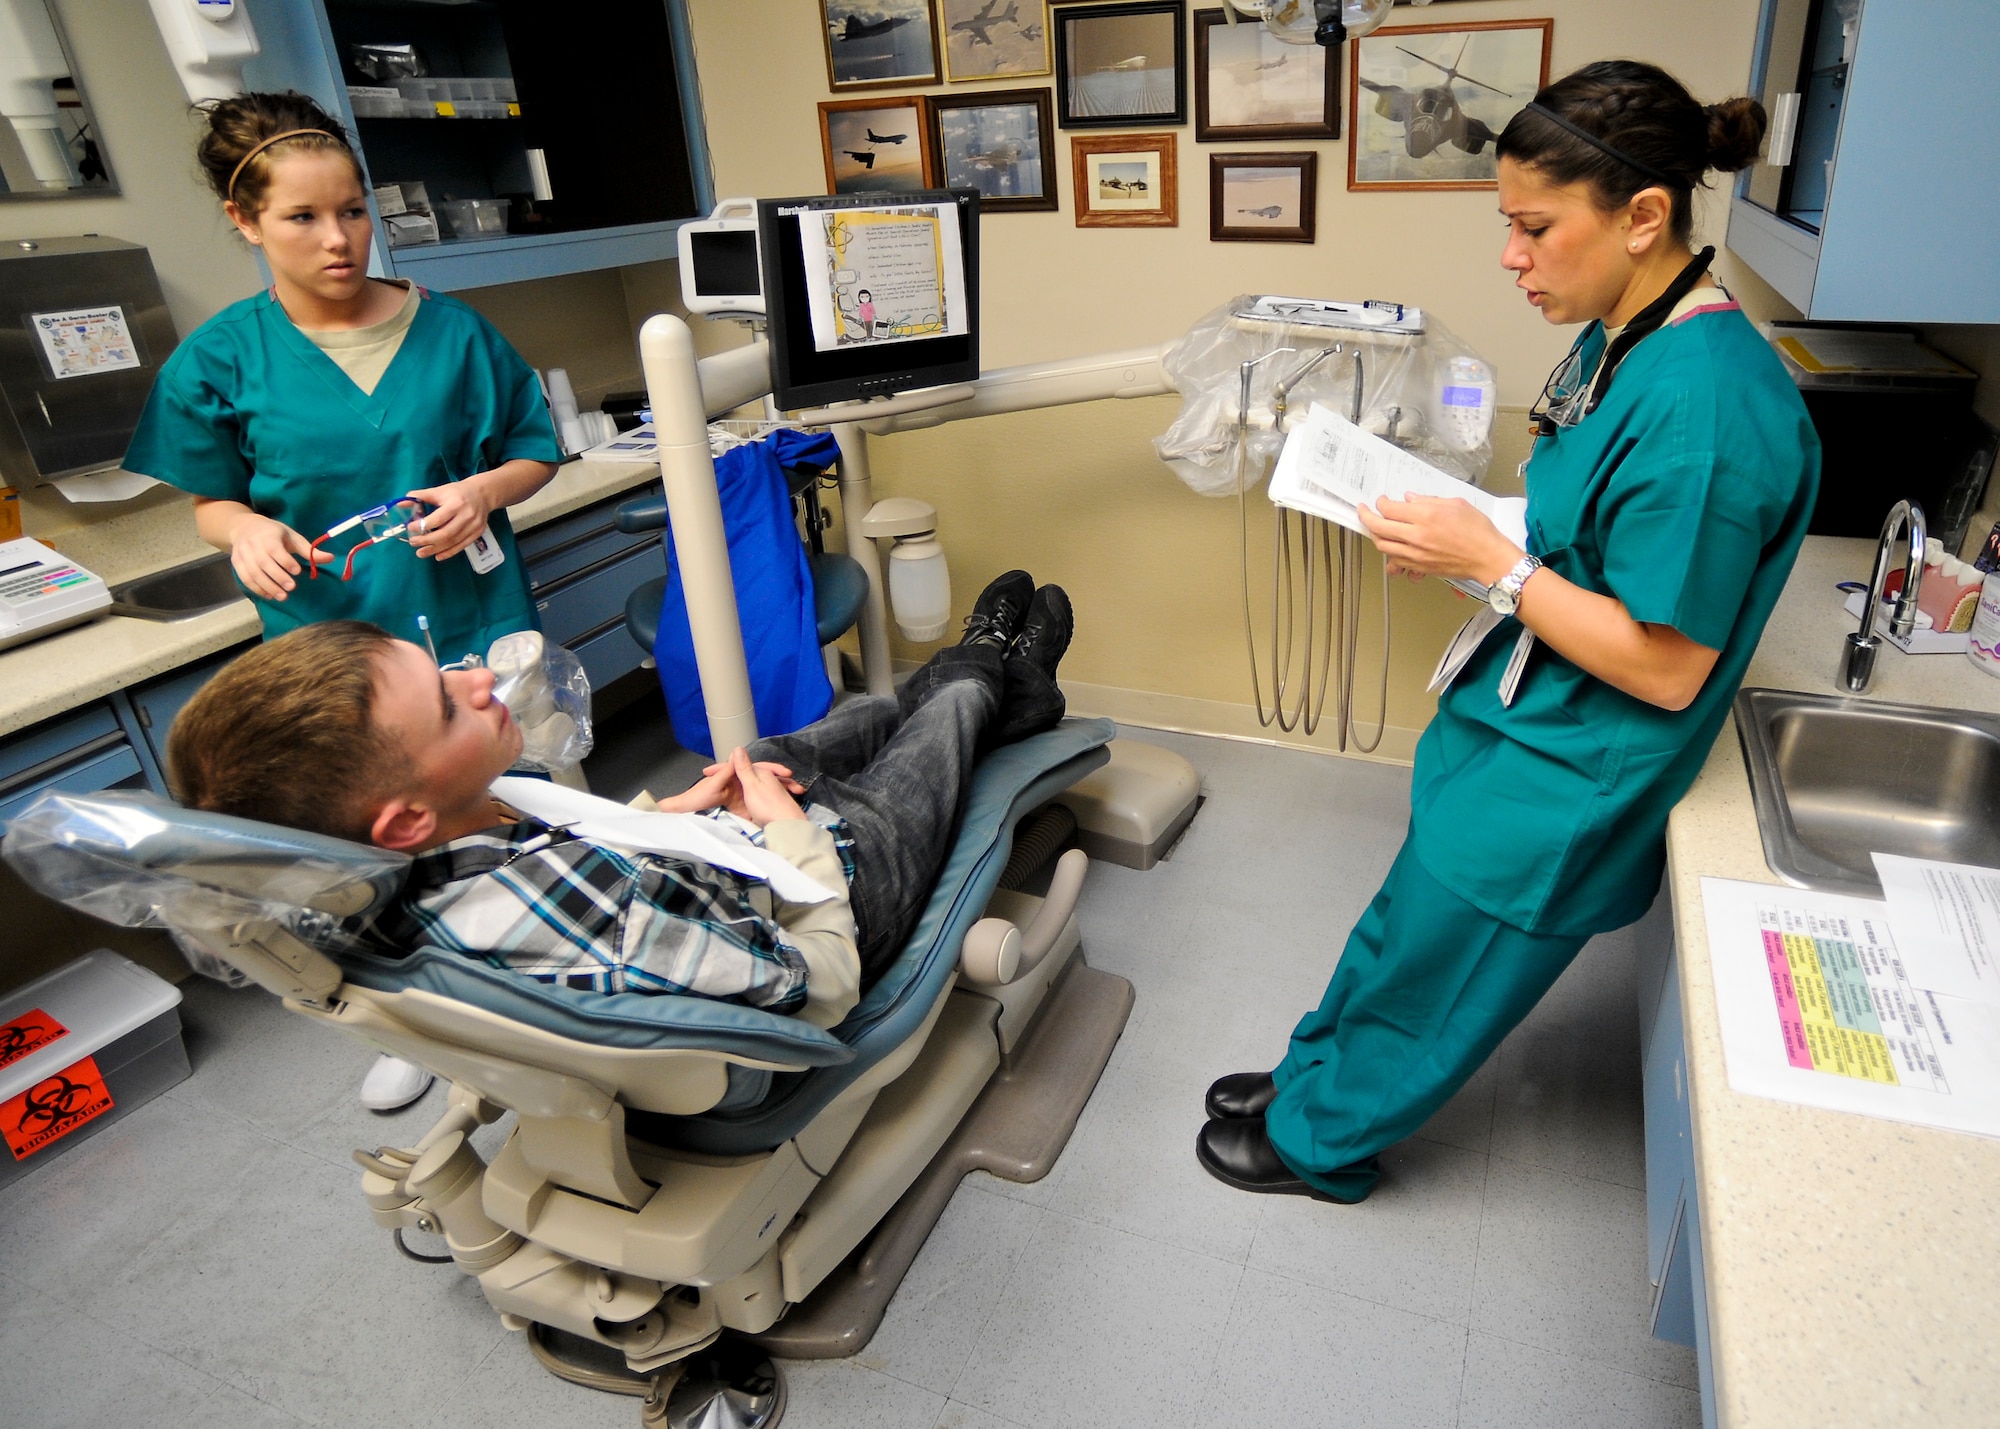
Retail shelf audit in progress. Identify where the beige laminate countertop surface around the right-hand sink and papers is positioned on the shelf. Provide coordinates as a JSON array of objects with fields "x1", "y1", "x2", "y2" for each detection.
[{"x1": 1666, "y1": 536, "x2": 2000, "y2": 1429}]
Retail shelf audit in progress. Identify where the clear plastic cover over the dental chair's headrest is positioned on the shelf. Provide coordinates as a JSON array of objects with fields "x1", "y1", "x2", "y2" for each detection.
[{"x1": 0, "y1": 791, "x2": 410, "y2": 987}]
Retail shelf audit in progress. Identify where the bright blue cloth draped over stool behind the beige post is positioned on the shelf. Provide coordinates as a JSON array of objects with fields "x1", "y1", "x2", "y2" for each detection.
[{"x1": 652, "y1": 430, "x2": 840, "y2": 755}]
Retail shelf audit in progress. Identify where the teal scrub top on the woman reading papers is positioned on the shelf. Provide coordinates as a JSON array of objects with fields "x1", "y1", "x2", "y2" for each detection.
[{"x1": 1410, "y1": 300, "x2": 1820, "y2": 935}]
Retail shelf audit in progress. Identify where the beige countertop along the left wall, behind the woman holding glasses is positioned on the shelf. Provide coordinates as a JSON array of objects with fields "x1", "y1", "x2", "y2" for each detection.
[{"x1": 0, "y1": 460, "x2": 660, "y2": 737}]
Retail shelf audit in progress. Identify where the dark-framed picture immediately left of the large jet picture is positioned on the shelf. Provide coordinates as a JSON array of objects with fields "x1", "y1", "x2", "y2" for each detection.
[{"x1": 1194, "y1": 10, "x2": 1346, "y2": 144}]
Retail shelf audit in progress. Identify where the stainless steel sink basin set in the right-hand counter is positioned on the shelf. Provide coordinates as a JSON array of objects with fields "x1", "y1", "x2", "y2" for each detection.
[{"x1": 1736, "y1": 690, "x2": 2000, "y2": 899}]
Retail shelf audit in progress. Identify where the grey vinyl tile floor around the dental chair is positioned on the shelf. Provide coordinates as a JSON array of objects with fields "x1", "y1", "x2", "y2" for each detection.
[{"x1": 0, "y1": 708, "x2": 1700, "y2": 1429}]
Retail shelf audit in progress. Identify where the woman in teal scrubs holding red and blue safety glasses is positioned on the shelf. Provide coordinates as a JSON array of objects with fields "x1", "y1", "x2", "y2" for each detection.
[{"x1": 124, "y1": 94, "x2": 562, "y2": 660}]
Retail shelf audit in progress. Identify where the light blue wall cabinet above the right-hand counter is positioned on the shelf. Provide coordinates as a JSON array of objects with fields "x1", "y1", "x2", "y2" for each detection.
[{"x1": 1728, "y1": 0, "x2": 2000, "y2": 322}]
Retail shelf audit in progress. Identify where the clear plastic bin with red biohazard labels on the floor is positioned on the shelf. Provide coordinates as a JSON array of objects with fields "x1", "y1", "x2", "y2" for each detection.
[{"x1": 0, "y1": 949, "x2": 188, "y2": 1187}]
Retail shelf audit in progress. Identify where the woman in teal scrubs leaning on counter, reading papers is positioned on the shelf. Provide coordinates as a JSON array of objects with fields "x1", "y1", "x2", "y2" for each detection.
[{"x1": 1196, "y1": 62, "x2": 1820, "y2": 1201}]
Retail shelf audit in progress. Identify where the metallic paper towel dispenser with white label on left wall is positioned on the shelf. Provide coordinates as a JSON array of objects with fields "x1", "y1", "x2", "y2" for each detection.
[{"x1": 0, "y1": 238, "x2": 180, "y2": 488}]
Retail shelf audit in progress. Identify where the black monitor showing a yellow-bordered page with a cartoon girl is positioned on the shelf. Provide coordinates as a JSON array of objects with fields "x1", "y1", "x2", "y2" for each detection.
[{"x1": 758, "y1": 188, "x2": 980, "y2": 410}]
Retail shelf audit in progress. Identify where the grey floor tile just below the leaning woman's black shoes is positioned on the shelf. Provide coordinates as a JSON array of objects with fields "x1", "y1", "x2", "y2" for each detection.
[{"x1": 1250, "y1": 1141, "x2": 1486, "y2": 1325}]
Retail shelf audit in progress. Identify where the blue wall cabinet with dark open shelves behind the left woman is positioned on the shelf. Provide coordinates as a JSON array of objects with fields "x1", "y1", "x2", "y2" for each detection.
[{"x1": 244, "y1": 0, "x2": 712, "y2": 290}]
